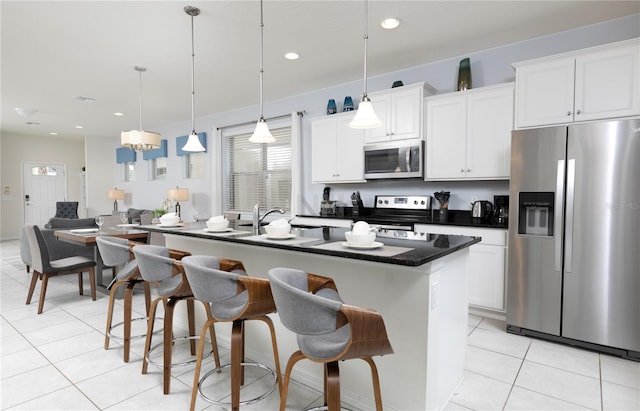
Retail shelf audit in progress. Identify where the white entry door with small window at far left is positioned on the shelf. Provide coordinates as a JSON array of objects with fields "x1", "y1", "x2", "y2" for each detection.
[{"x1": 22, "y1": 162, "x2": 67, "y2": 227}]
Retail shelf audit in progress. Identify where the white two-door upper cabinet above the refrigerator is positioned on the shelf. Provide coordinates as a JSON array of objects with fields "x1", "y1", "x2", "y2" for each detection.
[{"x1": 513, "y1": 39, "x2": 640, "y2": 128}]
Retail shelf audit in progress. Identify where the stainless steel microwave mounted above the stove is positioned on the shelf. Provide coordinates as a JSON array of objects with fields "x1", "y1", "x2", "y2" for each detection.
[{"x1": 364, "y1": 140, "x2": 424, "y2": 179}]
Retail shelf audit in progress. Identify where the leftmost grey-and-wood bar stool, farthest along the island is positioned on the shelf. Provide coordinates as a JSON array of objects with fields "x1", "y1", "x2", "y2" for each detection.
[{"x1": 96, "y1": 236, "x2": 151, "y2": 362}]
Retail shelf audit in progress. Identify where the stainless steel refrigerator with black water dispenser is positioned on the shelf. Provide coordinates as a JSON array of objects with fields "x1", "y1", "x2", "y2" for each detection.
[{"x1": 507, "y1": 119, "x2": 640, "y2": 359}]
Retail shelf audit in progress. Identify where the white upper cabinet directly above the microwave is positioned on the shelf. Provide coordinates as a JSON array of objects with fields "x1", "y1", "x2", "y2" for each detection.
[{"x1": 364, "y1": 82, "x2": 436, "y2": 144}]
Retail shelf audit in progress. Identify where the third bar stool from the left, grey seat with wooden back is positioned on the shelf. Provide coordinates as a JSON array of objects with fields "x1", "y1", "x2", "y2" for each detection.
[{"x1": 182, "y1": 255, "x2": 282, "y2": 411}]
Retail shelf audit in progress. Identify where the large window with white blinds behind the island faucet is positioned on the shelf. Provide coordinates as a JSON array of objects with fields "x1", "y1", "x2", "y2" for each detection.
[{"x1": 222, "y1": 126, "x2": 292, "y2": 213}]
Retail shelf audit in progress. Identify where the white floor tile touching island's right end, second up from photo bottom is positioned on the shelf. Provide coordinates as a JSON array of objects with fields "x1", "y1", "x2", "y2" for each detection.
[{"x1": 464, "y1": 346, "x2": 522, "y2": 384}]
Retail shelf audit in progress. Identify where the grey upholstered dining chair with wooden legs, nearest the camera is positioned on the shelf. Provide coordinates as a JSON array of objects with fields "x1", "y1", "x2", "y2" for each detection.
[{"x1": 24, "y1": 224, "x2": 96, "y2": 314}]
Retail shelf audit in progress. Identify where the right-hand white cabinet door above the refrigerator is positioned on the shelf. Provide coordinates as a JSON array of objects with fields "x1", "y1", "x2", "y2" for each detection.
[{"x1": 574, "y1": 44, "x2": 640, "y2": 121}]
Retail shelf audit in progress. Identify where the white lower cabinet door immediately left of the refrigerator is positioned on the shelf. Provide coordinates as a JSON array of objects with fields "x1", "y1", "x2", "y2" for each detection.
[{"x1": 469, "y1": 244, "x2": 506, "y2": 311}]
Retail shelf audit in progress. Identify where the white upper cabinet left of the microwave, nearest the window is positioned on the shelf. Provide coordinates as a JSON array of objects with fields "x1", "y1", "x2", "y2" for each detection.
[{"x1": 311, "y1": 112, "x2": 366, "y2": 183}]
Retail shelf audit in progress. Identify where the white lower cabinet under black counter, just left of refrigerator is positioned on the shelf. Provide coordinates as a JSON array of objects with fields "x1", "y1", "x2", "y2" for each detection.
[{"x1": 415, "y1": 224, "x2": 507, "y2": 313}]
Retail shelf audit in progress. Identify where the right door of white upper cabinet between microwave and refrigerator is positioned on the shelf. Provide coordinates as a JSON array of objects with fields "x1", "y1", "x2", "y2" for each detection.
[{"x1": 466, "y1": 84, "x2": 514, "y2": 179}]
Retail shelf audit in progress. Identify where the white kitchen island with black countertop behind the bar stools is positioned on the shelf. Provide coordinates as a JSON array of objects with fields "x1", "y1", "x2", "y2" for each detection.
[{"x1": 141, "y1": 222, "x2": 480, "y2": 411}]
